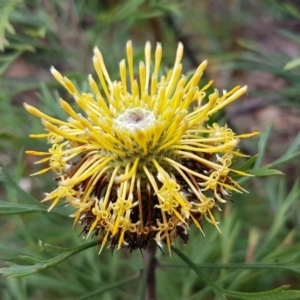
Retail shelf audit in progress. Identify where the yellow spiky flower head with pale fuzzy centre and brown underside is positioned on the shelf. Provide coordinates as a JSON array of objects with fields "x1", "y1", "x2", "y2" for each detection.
[{"x1": 25, "y1": 42, "x2": 257, "y2": 251}]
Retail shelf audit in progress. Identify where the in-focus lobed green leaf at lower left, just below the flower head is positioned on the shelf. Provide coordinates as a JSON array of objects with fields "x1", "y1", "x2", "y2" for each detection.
[{"x1": 0, "y1": 240, "x2": 98, "y2": 277}]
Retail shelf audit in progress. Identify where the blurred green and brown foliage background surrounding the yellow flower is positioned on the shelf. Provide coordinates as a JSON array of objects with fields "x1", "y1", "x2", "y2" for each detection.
[{"x1": 0, "y1": 0, "x2": 300, "y2": 300}]
